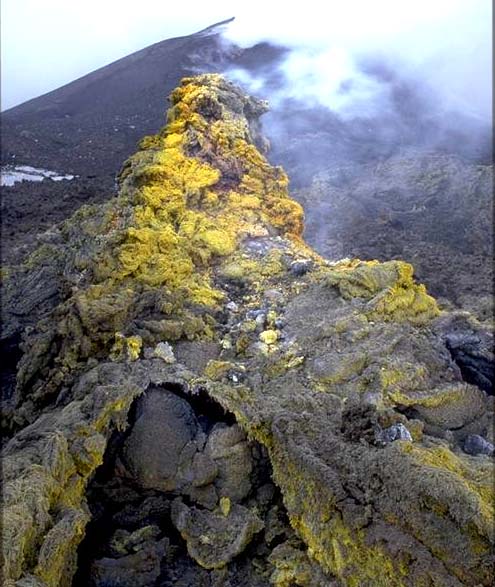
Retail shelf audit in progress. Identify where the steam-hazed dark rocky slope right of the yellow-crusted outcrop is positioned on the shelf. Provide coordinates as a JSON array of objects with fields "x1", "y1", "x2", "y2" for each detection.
[{"x1": 295, "y1": 150, "x2": 493, "y2": 319}]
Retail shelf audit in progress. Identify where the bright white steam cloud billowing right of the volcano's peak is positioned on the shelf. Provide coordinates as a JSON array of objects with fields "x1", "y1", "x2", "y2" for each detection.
[{"x1": 224, "y1": 0, "x2": 492, "y2": 123}]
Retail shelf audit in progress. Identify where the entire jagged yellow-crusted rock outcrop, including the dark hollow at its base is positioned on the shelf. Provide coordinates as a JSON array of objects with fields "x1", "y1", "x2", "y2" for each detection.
[{"x1": 3, "y1": 75, "x2": 494, "y2": 587}]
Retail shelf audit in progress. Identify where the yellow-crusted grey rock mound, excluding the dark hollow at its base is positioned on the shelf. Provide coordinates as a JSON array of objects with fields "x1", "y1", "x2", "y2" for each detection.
[{"x1": 3, "y1": 75, "x2": 494, "y2": 587}]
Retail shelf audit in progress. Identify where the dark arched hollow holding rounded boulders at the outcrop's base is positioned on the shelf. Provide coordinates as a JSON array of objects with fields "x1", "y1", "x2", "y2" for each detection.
[{"x1": 73, "y1": 384, "x2": 302, "y2": 587}]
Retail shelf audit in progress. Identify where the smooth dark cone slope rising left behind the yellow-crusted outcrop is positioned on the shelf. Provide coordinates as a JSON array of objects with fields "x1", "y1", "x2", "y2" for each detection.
[{"x1": 2, "y1": 20, "x2": 240, "y2": 177}]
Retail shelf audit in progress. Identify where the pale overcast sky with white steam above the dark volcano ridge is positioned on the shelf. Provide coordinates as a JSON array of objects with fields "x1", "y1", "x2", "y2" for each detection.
[{"x1": 1, "y1": 0, "x2": 492, "y2": 116}]
